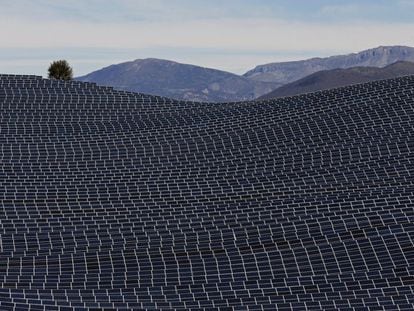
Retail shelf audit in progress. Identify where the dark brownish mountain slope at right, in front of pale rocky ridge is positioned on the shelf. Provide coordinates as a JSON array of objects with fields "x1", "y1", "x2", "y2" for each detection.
[{"x1": 260, "y1": 62, "x2": 414, "y2": 99}]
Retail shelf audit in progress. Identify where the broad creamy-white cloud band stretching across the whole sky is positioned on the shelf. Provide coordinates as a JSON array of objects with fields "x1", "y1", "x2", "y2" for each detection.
[{"x1": 0, "y1": 19, "x2": 414, "y2": 51}]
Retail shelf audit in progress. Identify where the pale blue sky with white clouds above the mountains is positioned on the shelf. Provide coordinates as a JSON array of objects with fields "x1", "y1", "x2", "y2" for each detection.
[{"x1": 0, "y1": 0, "x2": 414, "y2": 76}]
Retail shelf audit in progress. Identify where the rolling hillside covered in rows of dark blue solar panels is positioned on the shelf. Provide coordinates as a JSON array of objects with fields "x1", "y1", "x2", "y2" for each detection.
[{"x1": 0, "y1": 75, "x2": 414, "y2": 311}]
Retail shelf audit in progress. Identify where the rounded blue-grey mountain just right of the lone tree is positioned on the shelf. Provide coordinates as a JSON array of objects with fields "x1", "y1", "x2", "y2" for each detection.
[{"x1": 77, "y1": 58, "x2": 280, "y2": 102}]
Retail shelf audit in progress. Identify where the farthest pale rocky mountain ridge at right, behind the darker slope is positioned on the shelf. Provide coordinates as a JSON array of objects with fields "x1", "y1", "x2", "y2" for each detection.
[{"x1": 244, "y1": 46, "x2": 414, "y2": 84}]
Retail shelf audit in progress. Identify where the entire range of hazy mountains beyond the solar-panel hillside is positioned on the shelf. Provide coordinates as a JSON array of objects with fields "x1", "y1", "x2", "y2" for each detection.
[{"x1": 77, "y1": 46, "x2": 414, "y2": 102}]
